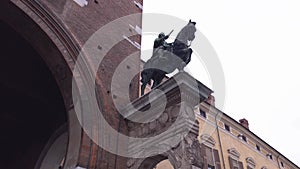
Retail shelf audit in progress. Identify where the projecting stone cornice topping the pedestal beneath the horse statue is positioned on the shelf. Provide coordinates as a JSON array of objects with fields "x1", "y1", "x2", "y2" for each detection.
[{"x1": 122, "y1": 72, "x2": 213, "y2": 118}]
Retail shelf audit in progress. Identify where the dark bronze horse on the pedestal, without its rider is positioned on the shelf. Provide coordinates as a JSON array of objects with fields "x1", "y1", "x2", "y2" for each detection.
[{"x1": 141, "y1": 20, "x2": 196, "y2": 95}]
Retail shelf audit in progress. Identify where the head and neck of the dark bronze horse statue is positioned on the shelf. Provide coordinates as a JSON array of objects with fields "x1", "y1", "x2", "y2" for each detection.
[{"x1": 176, "y1": 20, "x2": 197, "y2": 46}]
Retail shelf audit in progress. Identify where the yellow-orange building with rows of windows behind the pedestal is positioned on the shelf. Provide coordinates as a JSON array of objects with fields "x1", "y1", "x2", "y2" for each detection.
[{"x1": 156, "y1": 97, "x2": 299, "y2": 169}]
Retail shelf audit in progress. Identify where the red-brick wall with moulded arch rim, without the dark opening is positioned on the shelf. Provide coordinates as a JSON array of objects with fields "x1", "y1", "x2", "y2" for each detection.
[{"x1": 0, "y1": 0, "x2": 141, "y2": 168}]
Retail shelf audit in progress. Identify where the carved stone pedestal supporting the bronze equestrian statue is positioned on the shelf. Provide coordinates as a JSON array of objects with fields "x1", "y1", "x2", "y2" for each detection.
[{"x1": 123, "y1": 72, "x2": 212, "y2": 169}]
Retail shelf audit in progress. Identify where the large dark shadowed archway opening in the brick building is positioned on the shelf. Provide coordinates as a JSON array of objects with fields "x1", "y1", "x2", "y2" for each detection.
[{"x1": 0, "y1": 21, "x2": 67, "y2": 169}]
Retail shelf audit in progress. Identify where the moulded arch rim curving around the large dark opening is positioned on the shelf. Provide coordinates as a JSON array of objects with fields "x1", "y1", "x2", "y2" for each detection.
[{"x1": 0, "y1": 0, "x2": 82, "y2": 168}]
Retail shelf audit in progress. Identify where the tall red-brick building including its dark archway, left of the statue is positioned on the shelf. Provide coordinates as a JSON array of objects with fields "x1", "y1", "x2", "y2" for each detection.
[{"x1": 0, "y1": 0, "x2": 142, "y2": 169}]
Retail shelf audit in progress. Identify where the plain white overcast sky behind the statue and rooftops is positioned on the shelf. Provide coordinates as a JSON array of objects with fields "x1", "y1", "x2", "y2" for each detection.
[{"x1": 142, "y1": 0, "x2": 300, "y2": 166}]
